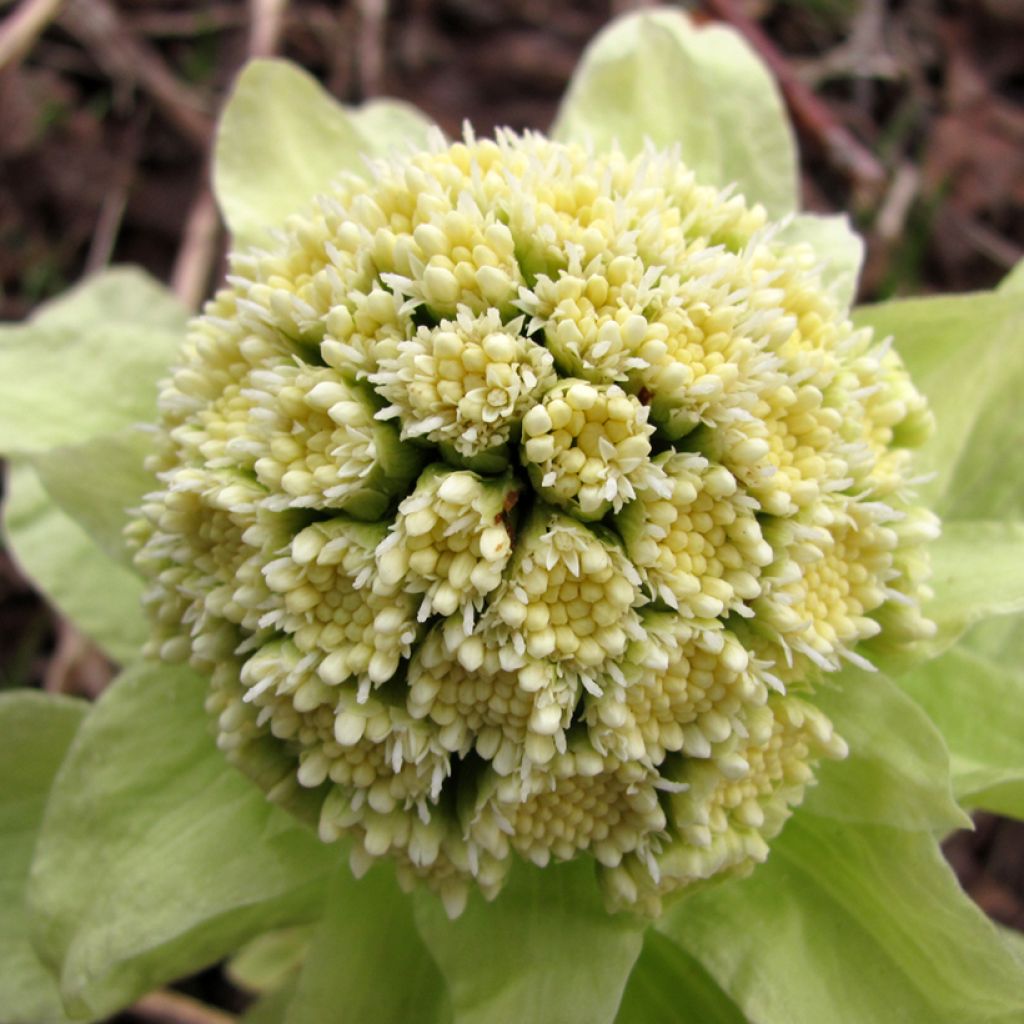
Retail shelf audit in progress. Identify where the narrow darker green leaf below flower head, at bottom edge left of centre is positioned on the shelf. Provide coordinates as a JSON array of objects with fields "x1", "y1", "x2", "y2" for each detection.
[{"x1": 285, "y1": 864, "x2": 452, "y2": 1024}]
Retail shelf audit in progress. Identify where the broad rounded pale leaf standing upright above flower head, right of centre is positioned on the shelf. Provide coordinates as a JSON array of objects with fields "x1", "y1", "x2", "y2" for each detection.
[{"x1": 552, "y1": 9, "x2": 798, "y2": 216}]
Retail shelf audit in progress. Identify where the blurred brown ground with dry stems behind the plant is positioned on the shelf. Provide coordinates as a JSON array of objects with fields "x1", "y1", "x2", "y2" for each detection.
[{"x1": 0, "y1": 0, "x2": 1024, "y2": 1024}]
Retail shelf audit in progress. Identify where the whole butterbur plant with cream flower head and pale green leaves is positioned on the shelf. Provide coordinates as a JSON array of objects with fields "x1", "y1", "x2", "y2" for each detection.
[{"x1": 0, "y1": 11, "x2": 1024, "y2": 1024}]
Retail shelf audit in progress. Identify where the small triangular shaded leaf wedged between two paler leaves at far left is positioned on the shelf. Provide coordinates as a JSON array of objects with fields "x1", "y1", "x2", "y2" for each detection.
[{"x1": 30, "y1": 427, "x2": 157, "y2": 567}]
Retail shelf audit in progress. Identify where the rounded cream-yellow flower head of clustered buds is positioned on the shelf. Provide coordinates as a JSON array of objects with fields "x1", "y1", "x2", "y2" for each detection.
[{"x1": 129, "y1": 132, "x2": 938, "y2": 913}]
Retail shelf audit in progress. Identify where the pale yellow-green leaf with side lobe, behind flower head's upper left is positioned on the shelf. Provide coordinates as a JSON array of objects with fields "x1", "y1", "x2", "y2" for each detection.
[{"x1": 213, "y1": 60, "x2": 438, "y2": 246}]
